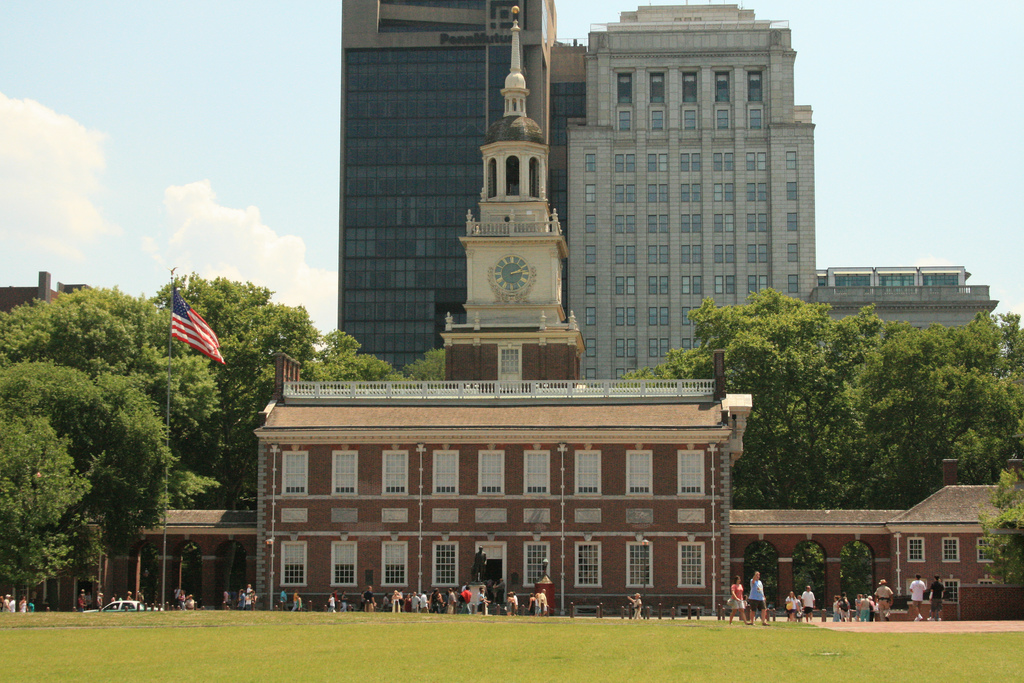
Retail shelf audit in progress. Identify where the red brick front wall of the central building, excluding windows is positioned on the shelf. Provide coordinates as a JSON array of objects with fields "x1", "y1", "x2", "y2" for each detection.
[{"x1": 263, "y1": 440, "x2": 723, "y2": 606}]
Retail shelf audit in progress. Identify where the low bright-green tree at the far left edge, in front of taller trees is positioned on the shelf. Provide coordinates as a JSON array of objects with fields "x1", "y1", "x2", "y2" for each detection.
[{"x1": 0, "y1": 412, "x2": 89, "y2": 586}]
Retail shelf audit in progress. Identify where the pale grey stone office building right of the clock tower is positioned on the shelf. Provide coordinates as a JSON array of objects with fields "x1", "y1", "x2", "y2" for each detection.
[{"x1": 567, "y1": 5, "x2": 816, "y2": 379}]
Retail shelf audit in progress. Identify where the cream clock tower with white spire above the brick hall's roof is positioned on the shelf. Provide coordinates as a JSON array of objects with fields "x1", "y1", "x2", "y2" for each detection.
[{"x1": 441, "y1": 7, "x2": 583, "y2": 381}]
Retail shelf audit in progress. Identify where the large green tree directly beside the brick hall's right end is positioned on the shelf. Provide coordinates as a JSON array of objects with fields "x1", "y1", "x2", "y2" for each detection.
[{"x1": 644, "y1": 290, "x2": 882, "y2": 508}]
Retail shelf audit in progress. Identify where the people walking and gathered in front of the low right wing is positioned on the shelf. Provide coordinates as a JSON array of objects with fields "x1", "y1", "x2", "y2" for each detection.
[{"x1": 727, "y1": 571, "x2": 945, "y2": 626}]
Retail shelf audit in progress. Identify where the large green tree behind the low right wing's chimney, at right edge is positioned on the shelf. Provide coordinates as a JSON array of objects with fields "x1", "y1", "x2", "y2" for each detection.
[{"x1": 855, "y1": 315, "x2": 1024, "y2": 509}]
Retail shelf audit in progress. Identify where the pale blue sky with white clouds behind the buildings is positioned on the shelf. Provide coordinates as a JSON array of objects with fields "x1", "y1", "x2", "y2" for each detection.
[{"x1": 0, "y1": 0, "x2": 1024, "y2": 331}]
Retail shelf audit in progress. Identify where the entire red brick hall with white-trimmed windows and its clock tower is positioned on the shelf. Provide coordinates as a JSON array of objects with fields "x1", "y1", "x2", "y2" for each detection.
[{"x1": 250, "y1": 17, "x2": 751, "y2": 609}]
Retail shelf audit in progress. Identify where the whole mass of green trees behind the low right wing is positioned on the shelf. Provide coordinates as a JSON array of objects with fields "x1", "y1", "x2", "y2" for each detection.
[{"x1": 637, "y1": 290, "x2": 1024, "y2": 509}]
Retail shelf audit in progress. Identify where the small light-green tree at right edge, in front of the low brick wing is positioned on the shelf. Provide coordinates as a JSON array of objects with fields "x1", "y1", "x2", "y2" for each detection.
[{"x1": 980, "y1": 469, "x2": 1024, "y2": 584}]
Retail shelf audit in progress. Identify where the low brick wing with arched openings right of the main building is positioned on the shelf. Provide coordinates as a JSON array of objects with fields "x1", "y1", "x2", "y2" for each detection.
[{"x1": 730, "y1": 460, "x2": 1024, "y2": 620}]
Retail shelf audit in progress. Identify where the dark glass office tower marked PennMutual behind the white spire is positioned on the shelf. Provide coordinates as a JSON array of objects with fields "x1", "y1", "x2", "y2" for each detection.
[{"x1": 338, "y1": 0, "x2": 555, "y2": 366}]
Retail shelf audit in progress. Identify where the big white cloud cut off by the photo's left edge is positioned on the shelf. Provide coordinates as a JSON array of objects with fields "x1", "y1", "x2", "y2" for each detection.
[{"x1": 0, "y1": 93, "x2": 121, "y2": 259}]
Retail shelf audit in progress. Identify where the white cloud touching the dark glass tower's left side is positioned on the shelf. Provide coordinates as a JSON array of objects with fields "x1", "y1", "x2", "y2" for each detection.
[{"x1": 159, "y1": 180, "x2": 338, "y2": 331}]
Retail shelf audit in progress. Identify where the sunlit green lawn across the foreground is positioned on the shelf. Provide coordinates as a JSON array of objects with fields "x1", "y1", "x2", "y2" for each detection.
[{"x1": 0, "y1": 611, "x2": 1024, "y2": 683}]
